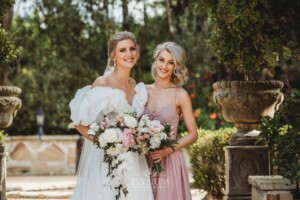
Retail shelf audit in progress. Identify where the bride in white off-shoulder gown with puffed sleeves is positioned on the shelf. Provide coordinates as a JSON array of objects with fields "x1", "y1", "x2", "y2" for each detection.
[{"x1": 70, "y1": 31, "x2": 153, "y2": 200}]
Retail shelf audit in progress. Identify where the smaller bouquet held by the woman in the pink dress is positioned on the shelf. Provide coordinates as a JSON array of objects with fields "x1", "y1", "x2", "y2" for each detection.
[{"x1": 137, "y1": 115, "x2": 177, "y2": 172}]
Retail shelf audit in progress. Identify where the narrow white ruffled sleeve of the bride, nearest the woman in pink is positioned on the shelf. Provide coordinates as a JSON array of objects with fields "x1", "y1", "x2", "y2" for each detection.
[{"x1": 132, "y1": 82, "x2": 148, "y2": 117}]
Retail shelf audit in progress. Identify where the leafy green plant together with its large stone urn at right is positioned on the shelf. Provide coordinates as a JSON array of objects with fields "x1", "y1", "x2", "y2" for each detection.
[{"x1": 194, "y1": 0, "x2": 300, "y2": 145}]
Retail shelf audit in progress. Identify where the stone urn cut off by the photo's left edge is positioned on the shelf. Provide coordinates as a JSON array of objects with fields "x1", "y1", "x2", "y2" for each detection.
[{"x1": 0, "y1": 86, "x2": 22, "y2": 128}]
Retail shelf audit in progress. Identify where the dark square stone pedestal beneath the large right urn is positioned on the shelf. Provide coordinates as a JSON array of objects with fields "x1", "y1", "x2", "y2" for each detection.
[{"x1": 223, "y1": 146, "x2": 269, "y2": 200}]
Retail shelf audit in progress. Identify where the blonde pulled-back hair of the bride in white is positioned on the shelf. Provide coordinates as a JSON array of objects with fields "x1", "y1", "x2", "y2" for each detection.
[{"x1": 107, "y1": 31, "x2": 139, "y2": 67}]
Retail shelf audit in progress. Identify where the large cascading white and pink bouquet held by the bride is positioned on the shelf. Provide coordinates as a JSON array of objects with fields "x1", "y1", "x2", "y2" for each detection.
[{"x1": 88, "y1": 112, "x2": 138, "y2": 199}]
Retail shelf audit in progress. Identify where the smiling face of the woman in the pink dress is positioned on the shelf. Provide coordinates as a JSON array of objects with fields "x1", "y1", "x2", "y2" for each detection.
[{"x1": 155, "y1": 50, "x2": 176, "y2": 80}]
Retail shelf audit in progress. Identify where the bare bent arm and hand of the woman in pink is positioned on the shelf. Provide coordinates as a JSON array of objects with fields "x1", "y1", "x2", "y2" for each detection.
[{"x1": 151, "y1": 88, "x2": 198, "y2": 162}]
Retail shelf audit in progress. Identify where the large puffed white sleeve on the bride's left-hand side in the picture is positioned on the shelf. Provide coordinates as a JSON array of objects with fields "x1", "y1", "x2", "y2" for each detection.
[{"x1": 69, "y1": 86, "x2": 128, "y2": 126}]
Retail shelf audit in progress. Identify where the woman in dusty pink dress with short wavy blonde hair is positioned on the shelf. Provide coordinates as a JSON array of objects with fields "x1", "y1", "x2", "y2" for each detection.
[{"x1": 145, "y1": 42, "x2": 197, "y2": 200}]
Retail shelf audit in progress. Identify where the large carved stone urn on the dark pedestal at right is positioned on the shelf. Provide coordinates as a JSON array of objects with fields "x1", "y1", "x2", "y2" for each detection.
[{"x1": 213, "y1": 80, "x2": 284, "y2": 146}]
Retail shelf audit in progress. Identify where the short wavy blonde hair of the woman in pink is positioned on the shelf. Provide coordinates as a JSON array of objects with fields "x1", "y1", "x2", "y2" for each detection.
[{"x1": 151, "y1": 42, "x2": 188, "y2": 86}]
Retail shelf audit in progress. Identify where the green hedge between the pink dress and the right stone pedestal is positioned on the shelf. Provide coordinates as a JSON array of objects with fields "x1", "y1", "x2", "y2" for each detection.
[{"x1": 189, "y1": 128, "x2": 236, "y2": 197}]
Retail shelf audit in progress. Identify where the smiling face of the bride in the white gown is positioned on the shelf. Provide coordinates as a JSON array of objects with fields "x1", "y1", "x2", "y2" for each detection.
[{"x1": 114, "y1": 39, "x2": 138, "y2": 68}]
